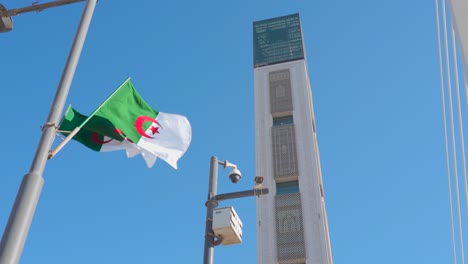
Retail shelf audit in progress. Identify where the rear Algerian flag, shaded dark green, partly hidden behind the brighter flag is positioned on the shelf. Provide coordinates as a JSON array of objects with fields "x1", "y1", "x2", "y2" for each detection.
[{"x1": 59, "y1": 106, "x2": 156, "y2": 168}]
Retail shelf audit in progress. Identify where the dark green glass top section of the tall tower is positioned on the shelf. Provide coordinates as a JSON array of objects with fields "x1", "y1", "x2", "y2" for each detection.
[{"x1": 253, "y1": 14, "x2": 304, "y2": 68}]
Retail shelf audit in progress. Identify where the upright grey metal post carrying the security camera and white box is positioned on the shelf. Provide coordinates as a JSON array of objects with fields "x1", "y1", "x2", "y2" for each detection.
[{"x1": 203, "y1": 156, "x2": 218, "y2": 264}]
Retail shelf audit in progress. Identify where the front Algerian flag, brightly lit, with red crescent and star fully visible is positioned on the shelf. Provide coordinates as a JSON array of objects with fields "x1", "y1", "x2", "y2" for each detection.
[{"x1": 57, "y1": 79, "x2": 192, "y2": 168}]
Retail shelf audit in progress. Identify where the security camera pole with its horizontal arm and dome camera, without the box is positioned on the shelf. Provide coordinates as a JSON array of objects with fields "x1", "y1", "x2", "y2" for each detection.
[{"x1": 203, "y1": 156, "x2": 268, "y2": 264}]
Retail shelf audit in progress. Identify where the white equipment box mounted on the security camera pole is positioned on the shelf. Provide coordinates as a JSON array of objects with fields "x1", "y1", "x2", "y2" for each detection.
[{"x1": 213, "y1": 206, "x2": 242, "y2": 245}]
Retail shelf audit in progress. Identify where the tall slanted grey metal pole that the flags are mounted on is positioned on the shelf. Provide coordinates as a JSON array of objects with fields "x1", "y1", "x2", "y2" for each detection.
[{"x1": 0, "y1": 0, "x2": 97, "y2": 264}]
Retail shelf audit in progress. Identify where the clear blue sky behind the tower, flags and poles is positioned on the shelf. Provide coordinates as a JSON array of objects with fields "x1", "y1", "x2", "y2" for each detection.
[{"x1": 0, "y1": 0, "x2": 453, "y2": 264}]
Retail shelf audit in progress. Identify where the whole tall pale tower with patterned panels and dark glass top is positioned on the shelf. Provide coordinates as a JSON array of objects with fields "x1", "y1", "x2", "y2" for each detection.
[{"x1": 253, "y1": 14, "x2": 332, "y2": 264}]
